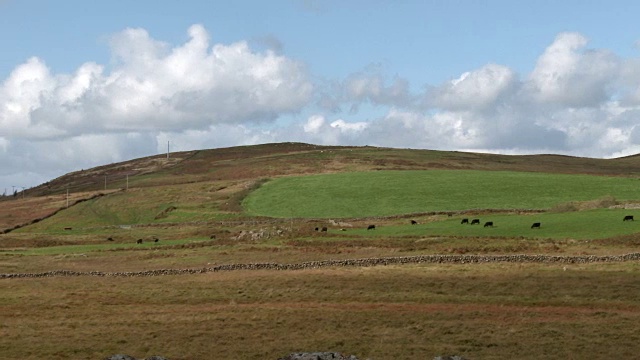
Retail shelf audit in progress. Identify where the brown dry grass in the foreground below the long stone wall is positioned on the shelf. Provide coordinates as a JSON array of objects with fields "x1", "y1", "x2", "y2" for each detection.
[{"x1": 0, "y1": 264, "x2": 640, "y2": 360}]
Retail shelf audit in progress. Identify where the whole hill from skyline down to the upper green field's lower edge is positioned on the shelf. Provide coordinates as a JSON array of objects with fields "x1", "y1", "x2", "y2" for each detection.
[{"x1": 0, "y1": 143, "x2": 640, "y2": 231}]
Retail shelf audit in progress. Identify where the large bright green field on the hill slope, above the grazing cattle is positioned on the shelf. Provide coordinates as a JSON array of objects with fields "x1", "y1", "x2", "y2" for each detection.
[{"x1": 243, "y1": 170, "x2": 640, "y2": 218}]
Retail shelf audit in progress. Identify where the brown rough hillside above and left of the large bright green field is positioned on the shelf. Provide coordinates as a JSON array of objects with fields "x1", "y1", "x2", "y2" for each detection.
[{"x1": 0, "y1": 143, "x2": 640, "y2": 230}]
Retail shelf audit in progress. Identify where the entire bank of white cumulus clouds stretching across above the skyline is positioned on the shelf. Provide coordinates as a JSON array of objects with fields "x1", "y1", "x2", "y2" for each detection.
[{"x1": 0, "y1": 25, "x2": 640, "y2": 191}]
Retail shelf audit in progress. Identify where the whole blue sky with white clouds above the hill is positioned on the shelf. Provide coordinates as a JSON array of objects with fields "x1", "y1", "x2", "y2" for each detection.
[{"x1": 0, "y1": 0, "x2": 640, "y2": 194}]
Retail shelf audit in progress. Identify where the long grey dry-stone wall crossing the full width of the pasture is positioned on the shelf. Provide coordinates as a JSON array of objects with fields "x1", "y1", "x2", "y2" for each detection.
[{"x1": 0, "y1": 253, "x2": 640, "y2": 279}]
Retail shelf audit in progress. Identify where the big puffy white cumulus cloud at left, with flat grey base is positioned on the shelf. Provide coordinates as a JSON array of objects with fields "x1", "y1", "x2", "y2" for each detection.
[{"x1": 0, "y1": 25, "x2": 313, "y2": 138}]
